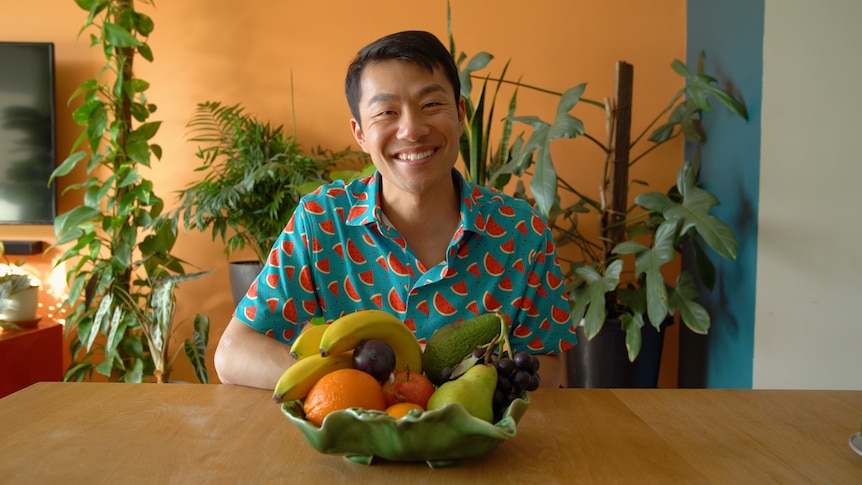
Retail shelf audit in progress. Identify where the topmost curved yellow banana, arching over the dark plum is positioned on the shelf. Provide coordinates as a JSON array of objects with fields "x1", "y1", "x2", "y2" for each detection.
[{"x1": 320, "y1": 310, "x2": 422, "y2": 373}]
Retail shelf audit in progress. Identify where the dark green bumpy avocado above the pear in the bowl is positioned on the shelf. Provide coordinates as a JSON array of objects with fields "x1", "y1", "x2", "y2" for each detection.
[{"x1": 422, "y1": 313, "x2": 503, "y2": 386}]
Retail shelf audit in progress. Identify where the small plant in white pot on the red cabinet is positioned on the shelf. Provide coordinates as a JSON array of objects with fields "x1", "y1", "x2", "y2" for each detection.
[{"x1": 0, "y1": 242, "x2": 39, "y2": 330}]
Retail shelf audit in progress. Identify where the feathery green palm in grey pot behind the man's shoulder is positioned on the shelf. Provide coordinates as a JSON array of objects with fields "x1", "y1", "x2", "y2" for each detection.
[{"x1": 171, "y1": 102, "x2": 373, "y2": 301}]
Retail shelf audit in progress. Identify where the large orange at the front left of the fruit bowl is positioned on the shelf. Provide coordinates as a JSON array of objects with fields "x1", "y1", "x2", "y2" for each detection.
[{"x1": 302, "y1": 369, "x2": 386, "y2": 427}]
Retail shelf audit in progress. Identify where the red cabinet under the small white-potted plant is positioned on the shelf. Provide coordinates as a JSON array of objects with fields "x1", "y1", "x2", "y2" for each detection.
[{"x1": 0, "y1": 319, "x2": 63, "y2": 397}]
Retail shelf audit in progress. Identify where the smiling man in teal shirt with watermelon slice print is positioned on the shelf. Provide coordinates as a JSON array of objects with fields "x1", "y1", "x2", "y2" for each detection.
[{"x1": 215, "y1": 31, "x2": 575, "y2": 389}]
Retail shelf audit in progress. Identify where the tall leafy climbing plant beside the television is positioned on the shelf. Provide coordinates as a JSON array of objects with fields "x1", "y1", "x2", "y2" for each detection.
[{"x1": 51, "y1": 0, "x2": 211, "y2": 382}]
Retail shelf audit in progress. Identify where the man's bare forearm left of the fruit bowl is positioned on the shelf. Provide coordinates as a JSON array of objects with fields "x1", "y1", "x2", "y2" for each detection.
[{"x1": 214, "y1": 317, "x2": 296, "y2": 389}]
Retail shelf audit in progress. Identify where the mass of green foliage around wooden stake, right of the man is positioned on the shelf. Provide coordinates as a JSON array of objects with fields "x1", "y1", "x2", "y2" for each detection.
[{"x1": 448, "y1": 1, "x2": 748, "y2": 361}]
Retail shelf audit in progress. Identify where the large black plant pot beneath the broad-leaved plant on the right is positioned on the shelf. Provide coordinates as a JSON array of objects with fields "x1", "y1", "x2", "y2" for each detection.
[{"x1": 566, "y1": 318, "x2": 673, "y2": 388}]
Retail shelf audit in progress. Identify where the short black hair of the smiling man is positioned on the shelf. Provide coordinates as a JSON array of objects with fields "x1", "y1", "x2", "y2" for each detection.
[{"x1": 344, "y1": 30, "x2": 461, "y2": 126}]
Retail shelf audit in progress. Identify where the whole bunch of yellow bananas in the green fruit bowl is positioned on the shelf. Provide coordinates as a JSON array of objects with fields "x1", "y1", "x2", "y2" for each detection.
[{"x1": 272, "y1": 310, "x2": 422, "y2": 403}]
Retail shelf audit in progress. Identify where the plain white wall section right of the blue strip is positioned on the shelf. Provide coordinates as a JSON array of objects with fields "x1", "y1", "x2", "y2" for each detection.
[{"x1": 753, "y1": 0, "x2": 862, "y2": 389}]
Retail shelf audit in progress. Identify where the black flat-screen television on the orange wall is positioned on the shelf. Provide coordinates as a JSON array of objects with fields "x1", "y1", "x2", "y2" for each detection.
[{"x1": 0, "y1": 41, "x2": 57, "y2": 225}]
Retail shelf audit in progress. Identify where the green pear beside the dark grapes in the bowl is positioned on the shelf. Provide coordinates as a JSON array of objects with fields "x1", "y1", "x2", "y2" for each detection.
[{"x1": 426, "y1": 364, "x2": 497, "y2": 423}]
